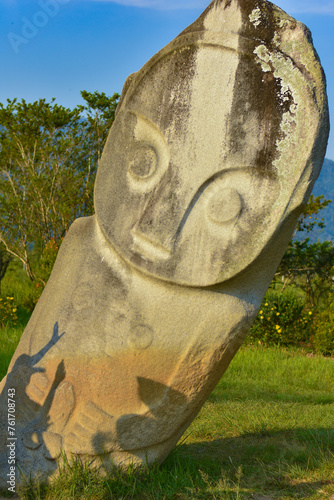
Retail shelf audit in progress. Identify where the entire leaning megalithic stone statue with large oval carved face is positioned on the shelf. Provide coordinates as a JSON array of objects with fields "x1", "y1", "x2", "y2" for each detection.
[{"x1": 0, "y1": 0, "x2": 329, "y2": 487}]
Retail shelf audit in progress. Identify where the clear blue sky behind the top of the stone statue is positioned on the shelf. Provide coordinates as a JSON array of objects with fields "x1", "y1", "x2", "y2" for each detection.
[{"x1": 0, "y1": 0, "x2": 334, "y2": 160}]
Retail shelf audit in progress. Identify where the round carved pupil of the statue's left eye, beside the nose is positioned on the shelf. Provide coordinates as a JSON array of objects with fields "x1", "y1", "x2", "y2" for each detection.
[{"x1": 128, "y1": 143, "x2": 158, "y2": 180}]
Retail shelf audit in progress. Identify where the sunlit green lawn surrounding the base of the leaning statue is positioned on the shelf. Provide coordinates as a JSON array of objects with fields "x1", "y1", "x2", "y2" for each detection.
[{"x1": 0, "y1": 331, "x2": 334, "y2": 500}]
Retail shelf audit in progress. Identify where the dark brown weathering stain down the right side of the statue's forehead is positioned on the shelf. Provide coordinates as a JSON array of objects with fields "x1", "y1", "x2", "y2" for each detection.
[{"x1": 229, "y1": 0, "x2": 293, "y2": 178}]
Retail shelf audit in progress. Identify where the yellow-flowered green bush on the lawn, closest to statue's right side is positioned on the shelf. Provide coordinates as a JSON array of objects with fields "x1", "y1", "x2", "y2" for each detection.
[{"x1": 247, "y1": 291, "x2": 313, "y2": 347}]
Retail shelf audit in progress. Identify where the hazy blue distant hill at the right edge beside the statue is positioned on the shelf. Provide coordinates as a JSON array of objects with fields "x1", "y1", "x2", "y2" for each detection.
[{"x1": 303, "y1": 158, "x2": 334, "y2": 241}]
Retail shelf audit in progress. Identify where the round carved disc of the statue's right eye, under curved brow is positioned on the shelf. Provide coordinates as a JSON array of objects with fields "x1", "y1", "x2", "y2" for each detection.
[{"x1": 206, "y1": 188, "x2": 242, "y2": 224}]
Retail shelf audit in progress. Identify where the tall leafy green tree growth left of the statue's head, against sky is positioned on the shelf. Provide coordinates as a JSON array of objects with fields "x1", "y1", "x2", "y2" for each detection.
[{"x1": 0, "y1": 91, "x2": 118, "y2": 284}]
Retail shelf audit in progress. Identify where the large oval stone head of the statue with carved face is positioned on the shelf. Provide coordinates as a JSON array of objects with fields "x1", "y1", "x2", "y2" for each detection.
[{"x1": 95, "y1": 0, "x2": 328, "y2": 286}]
